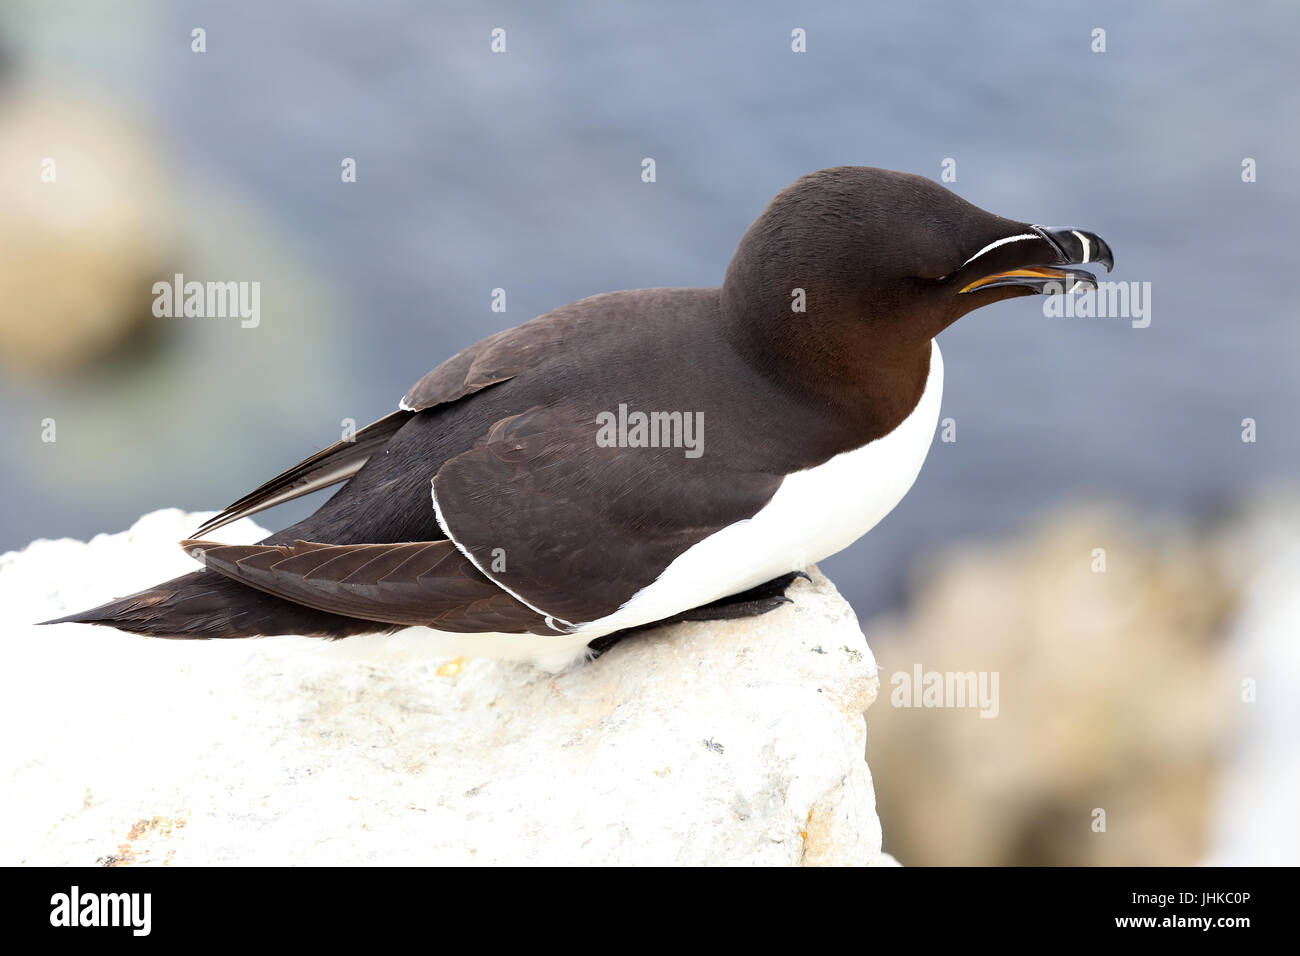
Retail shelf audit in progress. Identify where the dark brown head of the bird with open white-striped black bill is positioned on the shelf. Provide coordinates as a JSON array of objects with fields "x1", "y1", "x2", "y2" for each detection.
[{"x1": 723, "y1": 166, "x2": 1114, "y2": 362}]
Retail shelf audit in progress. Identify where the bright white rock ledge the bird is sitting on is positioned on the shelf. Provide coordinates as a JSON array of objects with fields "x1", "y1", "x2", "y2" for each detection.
[{"x1": 0, "y1": 510, "x2": 892, "y2": 865}]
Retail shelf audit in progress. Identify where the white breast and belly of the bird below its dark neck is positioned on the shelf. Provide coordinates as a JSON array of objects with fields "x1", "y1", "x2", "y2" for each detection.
[{"x1": 576, "y1": 342, "x2": 944, "y2": 640}]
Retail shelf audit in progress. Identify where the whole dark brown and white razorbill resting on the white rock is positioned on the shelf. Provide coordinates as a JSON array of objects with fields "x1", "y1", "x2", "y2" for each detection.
[{"x1": 47, "y1": 166, "x2": 1113, "y2": 670}]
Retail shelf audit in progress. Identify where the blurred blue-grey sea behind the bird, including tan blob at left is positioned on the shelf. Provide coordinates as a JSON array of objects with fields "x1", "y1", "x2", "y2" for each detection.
[{"x1": 0, "y1": 0, "x2": 1300, "y2": 868}]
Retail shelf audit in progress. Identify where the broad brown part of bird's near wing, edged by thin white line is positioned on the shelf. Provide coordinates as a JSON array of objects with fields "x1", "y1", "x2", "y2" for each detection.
[{"x1": 433, "y1": 406, "x2": 783, "y2": 627}]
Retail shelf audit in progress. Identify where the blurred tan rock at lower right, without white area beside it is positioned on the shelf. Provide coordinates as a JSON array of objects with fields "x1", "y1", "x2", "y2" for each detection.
[{"x1": 867, "y1": 509, "x2": 1235, "y2": 865}]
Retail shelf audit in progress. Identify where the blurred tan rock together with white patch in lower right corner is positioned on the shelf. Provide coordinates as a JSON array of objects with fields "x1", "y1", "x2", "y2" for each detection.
[{"x1": 867, "y1": 494, "x2": 1300, "y2": 865}]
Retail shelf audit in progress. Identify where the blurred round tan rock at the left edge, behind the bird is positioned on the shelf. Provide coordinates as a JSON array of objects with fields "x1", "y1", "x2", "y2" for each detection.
[{"x1": 0, "y1": 87, "x2": 172, "y2": 376}]
